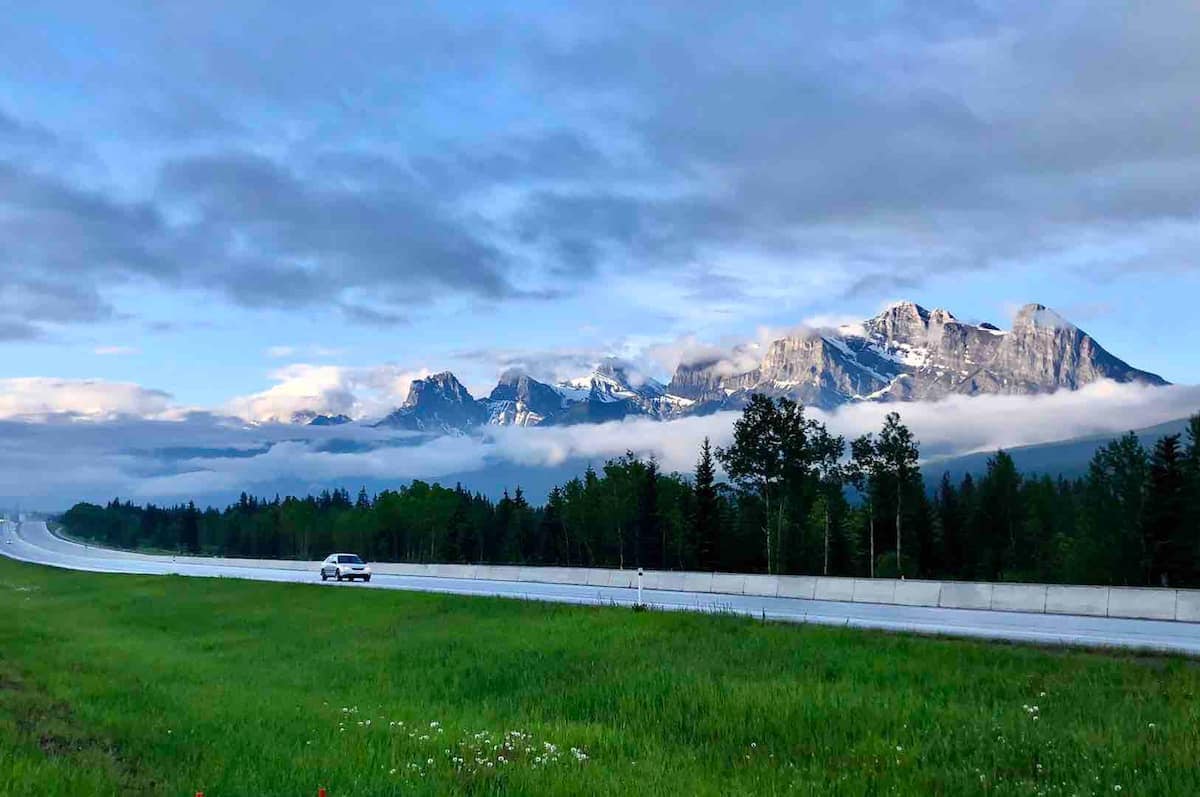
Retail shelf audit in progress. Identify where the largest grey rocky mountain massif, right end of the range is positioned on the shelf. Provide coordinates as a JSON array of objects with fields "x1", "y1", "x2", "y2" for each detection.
[{"x1": 667, "y1": 302, "x2": 1166, "y2": 408}]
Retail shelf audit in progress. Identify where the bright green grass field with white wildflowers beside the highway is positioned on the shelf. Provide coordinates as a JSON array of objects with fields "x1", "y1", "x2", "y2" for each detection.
[{"x1": 0, "y1": 561, "x2": 1200, "y2": 797}]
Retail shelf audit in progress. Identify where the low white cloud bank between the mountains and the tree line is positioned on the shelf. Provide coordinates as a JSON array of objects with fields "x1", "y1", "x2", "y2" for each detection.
[{"x1": 0, "y1": 383, "x2": 1200, "y2": 509}]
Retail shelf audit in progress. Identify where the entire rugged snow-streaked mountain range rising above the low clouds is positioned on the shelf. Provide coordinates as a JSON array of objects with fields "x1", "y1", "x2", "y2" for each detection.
[{"x1": 293, "y1": 301, "x2": 1168, "y2": 433}]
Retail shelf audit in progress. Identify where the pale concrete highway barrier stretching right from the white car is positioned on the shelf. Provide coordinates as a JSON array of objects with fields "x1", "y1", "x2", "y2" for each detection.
[{"x1": 371, "y1": 563, "x2": 1200, "y2": 623}]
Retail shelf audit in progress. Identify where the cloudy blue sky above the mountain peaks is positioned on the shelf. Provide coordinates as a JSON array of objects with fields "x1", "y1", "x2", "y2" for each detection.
[{"x1": 0, "y1": 0, "x2": 1200, "y2": 417}]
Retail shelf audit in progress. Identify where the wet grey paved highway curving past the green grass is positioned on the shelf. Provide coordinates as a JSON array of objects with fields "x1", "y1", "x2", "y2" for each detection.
[{"x1": 7, "y1": 521, "x2": 1200, "y2": 655}]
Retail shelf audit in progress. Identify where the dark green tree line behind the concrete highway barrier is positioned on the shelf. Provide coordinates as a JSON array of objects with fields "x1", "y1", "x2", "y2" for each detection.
[{"x1": 61, "y1": 395, "x2": 1200, "y2": 586}]
